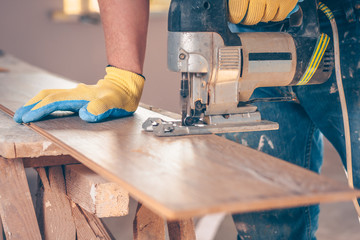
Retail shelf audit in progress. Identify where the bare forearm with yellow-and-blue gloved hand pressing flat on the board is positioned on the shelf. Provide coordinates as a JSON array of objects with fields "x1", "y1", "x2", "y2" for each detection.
[{"x1": 14, "y1": 0, "x2": 149, "y2": 122}]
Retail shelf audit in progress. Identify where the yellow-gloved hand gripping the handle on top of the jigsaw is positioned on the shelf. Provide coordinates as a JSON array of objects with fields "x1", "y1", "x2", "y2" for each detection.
[{"x1": 229, "y1": 0, "x2": 298, "y2": 25}]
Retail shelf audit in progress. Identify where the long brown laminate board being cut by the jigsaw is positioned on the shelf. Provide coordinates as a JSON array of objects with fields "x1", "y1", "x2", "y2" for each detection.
[{"x1": 0, "y1": 55, "x2": 359, "y2": 219}]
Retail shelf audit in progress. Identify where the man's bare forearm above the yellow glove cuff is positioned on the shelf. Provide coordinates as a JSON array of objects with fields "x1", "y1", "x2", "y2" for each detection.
[{"x1": 98, "y1": 0, "x2": 149, "y2": 74}]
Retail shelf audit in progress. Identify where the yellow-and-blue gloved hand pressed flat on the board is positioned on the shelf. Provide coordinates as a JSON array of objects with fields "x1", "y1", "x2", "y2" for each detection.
[{"x1": 14, "y1": 67, "x2": 145, "y2": 123}]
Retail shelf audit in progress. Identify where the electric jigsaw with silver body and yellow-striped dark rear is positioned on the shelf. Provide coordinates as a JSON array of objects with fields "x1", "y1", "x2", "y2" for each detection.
[{"x1": 143, "y1": 0, "x2": 334, "y2": 136}]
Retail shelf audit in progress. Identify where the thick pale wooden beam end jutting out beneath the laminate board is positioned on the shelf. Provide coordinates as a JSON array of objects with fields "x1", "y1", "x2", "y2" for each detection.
[{"x1": 65, "y1": 164, "x2": 129, "y2": 218}]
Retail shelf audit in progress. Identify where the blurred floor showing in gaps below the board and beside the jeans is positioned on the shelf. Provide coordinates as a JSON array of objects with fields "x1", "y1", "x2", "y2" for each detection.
[{"x1": 27, "y1": 138, "x2": 360, "y2": 240}]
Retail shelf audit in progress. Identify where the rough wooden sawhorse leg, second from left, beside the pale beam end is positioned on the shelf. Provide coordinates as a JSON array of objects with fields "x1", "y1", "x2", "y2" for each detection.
[{"x1": 36, "y1": 167, "x2": 76, "y2": 240}]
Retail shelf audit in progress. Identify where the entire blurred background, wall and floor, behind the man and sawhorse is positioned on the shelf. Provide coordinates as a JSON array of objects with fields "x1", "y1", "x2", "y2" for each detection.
[{"x1": 0, "y1": 0, "x2": 360, "y2": 240}]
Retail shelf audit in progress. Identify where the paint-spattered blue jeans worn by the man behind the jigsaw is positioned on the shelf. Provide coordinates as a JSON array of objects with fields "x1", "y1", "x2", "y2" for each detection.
[{"x1": 225, "y1": 23, "x2": 360, "y2": 240}]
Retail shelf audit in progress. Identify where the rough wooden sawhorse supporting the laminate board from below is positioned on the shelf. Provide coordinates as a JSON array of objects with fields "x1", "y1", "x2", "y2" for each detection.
[{"x1": 0, "y1": 108, "x2": 195, "y2": 240}]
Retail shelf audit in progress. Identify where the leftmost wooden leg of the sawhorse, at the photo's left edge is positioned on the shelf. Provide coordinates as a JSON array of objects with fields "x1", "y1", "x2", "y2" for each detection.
[{"x1": 0, "y1": 157, "x2": 41, "y2": 240}]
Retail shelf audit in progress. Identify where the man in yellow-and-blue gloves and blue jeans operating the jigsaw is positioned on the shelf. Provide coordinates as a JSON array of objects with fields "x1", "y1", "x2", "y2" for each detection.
[{"x1": 14, "y1": 0, "x2": 360, "y2": 240}]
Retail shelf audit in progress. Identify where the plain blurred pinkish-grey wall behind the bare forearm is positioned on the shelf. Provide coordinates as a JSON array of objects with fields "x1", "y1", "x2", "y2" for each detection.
[{"x1": 0, "y1": 0, "x2": 180, "y2": 112}]
